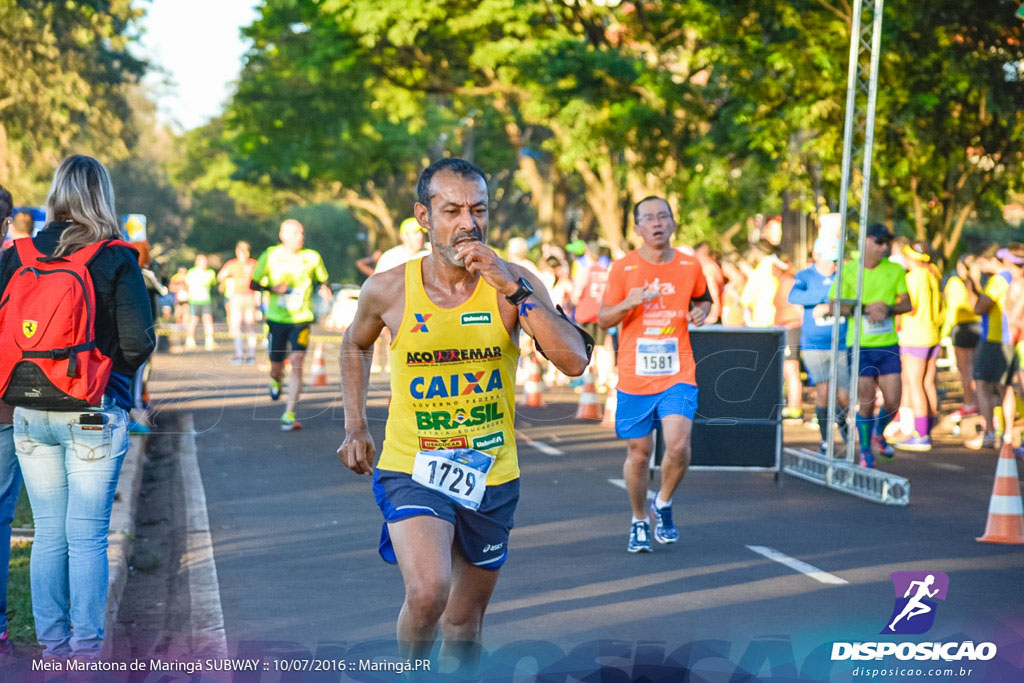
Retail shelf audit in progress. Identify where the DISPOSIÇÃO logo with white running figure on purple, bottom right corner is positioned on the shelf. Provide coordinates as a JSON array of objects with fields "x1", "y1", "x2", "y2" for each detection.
[{"x1": 831, "y1": 571, "x2": 996, "y2": 661}]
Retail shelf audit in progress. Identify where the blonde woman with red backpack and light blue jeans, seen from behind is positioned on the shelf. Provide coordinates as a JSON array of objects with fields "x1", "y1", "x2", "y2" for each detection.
[{"x1": 0, "y1": 156, "x2": 155, "y2": 659}]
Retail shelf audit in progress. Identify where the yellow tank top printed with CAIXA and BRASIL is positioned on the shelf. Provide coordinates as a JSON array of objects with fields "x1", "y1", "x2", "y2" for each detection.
[{"x1": 377, "y1": 258, "x2": 519, "y2": 486}]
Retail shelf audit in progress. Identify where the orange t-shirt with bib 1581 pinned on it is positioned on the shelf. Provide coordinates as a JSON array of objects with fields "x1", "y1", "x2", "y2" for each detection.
[{"x1": 603, "y1": 251, "x2": 708, "y2": 395}]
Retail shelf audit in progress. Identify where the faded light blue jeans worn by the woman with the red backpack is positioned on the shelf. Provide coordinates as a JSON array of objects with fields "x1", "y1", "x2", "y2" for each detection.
[{"x1": 14, "y1": 408, "x2": 129, "y2": 656}]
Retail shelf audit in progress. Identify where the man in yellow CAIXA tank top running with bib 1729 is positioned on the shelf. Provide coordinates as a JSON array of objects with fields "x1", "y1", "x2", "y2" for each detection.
[{"x1": 338, "y1": 159, "x2": 590, "y2": 673}]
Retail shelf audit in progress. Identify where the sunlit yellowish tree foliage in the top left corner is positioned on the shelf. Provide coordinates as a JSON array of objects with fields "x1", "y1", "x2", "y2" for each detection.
[{"x1": 0, "y1": 0, "x2": 144, "y2": 204}]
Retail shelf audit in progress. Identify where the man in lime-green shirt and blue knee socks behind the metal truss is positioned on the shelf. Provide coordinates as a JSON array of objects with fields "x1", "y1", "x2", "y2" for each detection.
[{"x1": 829, "y1": 223, "x2": 911, "y2": 467}]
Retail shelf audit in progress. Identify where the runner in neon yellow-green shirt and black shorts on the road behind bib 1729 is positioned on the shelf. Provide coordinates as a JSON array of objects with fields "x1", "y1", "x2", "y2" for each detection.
[{"x1": 252, "y1": 219, "x2": 328, "y2": 431}]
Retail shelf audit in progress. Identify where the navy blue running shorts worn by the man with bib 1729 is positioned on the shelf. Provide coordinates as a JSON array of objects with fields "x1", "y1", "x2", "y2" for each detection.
[{"x1": 374, "y1": 469, "x2": 519, "y2": 569}]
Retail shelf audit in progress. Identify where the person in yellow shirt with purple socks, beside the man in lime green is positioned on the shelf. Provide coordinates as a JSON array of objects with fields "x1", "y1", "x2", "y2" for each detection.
[{"x1": 896, "y1": 242, "x2": 943, "y2": 451}]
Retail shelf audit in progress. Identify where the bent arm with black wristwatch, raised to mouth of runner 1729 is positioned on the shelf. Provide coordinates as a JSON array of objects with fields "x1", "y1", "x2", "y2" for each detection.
[{"x1": 458, "y1": 242, "x2": 590, "y2": 377}]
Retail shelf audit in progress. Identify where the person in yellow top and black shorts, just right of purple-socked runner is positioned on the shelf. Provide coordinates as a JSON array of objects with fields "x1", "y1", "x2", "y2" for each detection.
[{"x1": 942, "y1": 254, "x2": 981, "y2": 422}]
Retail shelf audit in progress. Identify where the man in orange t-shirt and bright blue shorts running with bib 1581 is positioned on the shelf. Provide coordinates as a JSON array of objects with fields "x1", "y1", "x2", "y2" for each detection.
[{"x1": 597, "y1": 197, "x2": 712, "y2": 553}]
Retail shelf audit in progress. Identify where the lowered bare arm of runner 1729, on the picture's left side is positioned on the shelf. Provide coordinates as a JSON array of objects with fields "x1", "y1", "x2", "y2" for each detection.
[{"x1": 338, "y1": 273, "x2": 396, "y2": 474}]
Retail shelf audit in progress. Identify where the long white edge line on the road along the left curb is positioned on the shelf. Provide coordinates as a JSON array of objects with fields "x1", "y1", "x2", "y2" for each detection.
[{"x1": 178, "y1": 413, "x2": 227, "y2": 658}]
